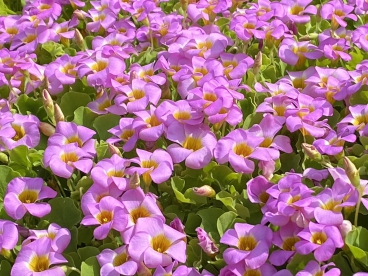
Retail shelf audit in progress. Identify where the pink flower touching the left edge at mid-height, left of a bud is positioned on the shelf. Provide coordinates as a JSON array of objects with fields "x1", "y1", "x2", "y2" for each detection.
[{"x1": 0, "y1": 113, "x2": 40, "y2": 149}]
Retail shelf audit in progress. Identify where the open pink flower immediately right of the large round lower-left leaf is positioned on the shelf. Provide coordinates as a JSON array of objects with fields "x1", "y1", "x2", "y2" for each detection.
[{"x1": 81, "y1": 196, "x2": 127, "y2": 240}]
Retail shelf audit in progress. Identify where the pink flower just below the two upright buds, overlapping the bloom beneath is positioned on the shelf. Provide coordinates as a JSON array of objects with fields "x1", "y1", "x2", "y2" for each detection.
[{"x1": 47, "y1": 122, "x2": 96, "y2": 157}]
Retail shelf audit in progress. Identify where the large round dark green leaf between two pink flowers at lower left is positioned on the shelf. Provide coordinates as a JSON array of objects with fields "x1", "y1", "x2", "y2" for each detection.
[{"x1": 43, "y1": 197, "x2": 82, "y2": 228}]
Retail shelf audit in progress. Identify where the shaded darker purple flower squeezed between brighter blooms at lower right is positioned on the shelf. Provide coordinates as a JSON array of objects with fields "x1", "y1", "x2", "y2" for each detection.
[{"x1": 269, "y1": 222, "x2": 303, "y2": 266}]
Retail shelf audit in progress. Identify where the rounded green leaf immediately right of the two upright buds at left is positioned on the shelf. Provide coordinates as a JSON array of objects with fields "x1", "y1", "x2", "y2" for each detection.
[{"x1": 60, "y1": 91, "x2": 91, "y2": 117}]
